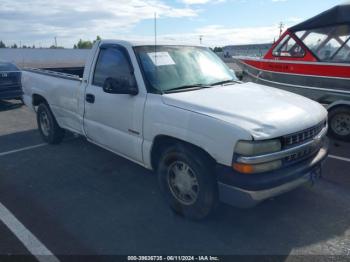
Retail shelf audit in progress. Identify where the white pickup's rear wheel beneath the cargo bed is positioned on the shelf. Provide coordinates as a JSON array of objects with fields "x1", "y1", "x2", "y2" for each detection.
[{"x1": 36, "y1": 103, "x2": 65, "y2": 144}]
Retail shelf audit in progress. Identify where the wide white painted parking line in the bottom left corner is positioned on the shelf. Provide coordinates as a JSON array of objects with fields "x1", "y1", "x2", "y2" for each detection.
[{"x1": 0, "y1": 203, "x2": 59, "y2": 262}]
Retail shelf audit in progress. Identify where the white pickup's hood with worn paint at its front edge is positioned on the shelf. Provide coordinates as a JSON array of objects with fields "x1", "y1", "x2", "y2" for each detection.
[{"x1": 162, "y1": 83, "x2": 327, "y2": 140}]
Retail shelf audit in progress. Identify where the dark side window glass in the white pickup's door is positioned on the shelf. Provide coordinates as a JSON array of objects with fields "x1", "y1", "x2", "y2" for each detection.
[{"x1": 92, "y1": 48, "x2": 135, "y2": 87}]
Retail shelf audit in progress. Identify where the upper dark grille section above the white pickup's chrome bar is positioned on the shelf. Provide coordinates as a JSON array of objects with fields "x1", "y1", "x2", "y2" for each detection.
[{"x1": 283, "y1": 122, "x2": 326, "y2": 148}]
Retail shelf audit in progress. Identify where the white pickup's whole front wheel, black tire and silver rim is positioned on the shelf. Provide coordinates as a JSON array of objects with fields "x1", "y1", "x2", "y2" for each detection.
[{"x1": 158, "y1": 145, "x2": 218, "y2": 220}]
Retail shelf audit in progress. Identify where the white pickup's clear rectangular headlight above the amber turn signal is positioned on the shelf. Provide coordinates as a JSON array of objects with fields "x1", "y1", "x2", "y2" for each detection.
[{"x1": 235, "y1": 139, "x2": 282, "y2": 156}]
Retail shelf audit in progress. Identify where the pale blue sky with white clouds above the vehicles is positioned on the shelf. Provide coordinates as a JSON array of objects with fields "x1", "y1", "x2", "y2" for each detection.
[{"x1": 0, "y1": 0, "x2": 344, "y2": 47}]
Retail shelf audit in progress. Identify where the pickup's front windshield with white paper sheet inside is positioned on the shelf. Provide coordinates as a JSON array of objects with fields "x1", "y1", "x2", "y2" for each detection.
[{"x1": 135, "y1": 46, "x2": 237, "y2": 92}]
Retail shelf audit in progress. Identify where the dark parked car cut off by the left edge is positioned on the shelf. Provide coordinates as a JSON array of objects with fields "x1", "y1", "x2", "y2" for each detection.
[{"x1": 0, "y1": 61, "x2": 23, "y2": 100}]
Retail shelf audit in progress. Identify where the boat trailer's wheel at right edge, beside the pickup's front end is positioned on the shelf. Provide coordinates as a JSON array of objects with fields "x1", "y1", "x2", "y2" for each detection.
[{"x1": 328, "y1": 106, "x2": 350, "y2": 142}]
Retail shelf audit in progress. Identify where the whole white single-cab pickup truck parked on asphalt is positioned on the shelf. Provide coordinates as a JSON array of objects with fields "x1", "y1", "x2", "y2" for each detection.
[{"x1": 22, "y1": 40, "x2": 328, "y2": 219}]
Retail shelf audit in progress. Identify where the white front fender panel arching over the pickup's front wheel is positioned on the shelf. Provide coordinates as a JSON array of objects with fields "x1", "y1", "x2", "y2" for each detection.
[{"x1": 143, "y1": 96, "x2": 252, "y2": 169}]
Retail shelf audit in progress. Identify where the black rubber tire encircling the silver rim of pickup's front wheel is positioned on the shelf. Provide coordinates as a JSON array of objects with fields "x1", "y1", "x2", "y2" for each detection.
[{"x1": 157, "y1": 144, "x2": 218, "y2": 220}]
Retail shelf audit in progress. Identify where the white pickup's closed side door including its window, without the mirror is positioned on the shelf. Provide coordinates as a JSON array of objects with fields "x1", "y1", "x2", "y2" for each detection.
[{"x1": 84, "y1": 45, "x2": 146, "y2": 162}]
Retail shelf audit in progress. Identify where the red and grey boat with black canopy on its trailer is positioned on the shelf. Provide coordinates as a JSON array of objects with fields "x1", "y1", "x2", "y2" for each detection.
[{"x1": 233, "y1": 4, "x2": 350, "y2": 141}]
